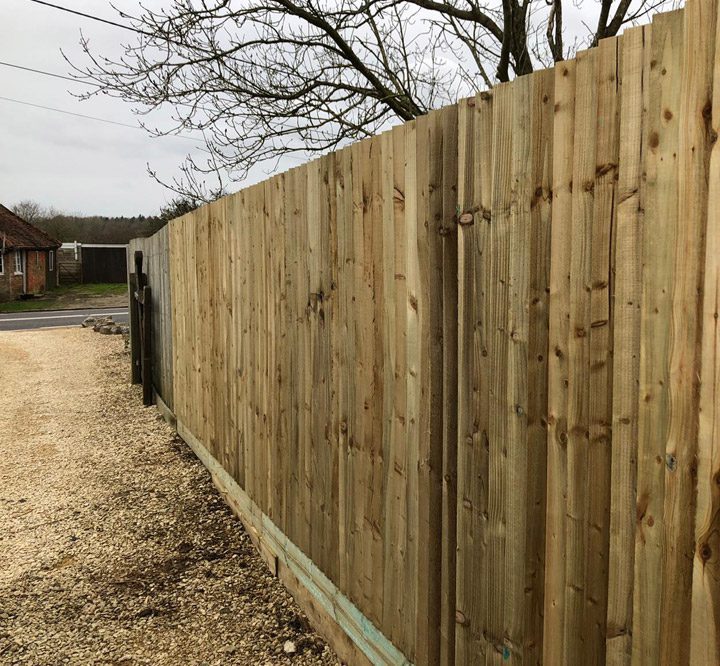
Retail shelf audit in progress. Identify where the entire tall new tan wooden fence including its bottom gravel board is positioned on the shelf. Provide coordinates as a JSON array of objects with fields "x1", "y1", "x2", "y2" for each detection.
[{"x1": 132, "y1": 0, "x2": 720, "y2": 665}]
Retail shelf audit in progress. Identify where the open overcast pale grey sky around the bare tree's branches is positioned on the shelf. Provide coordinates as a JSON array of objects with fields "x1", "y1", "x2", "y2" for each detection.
[{"x1": 0, "y1": 0, "x2": 676, "y2": 215}]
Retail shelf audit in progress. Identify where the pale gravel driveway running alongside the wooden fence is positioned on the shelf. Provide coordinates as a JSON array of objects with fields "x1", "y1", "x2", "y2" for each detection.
[{"x1": 0, "y1": 328, "x2": 338, "y2": 666}]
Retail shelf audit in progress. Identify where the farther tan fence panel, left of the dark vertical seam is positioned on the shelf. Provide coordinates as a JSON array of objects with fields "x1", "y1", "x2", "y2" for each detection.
[{"x1": 170, "y1": 107, "x2": 457, "y2": 662}]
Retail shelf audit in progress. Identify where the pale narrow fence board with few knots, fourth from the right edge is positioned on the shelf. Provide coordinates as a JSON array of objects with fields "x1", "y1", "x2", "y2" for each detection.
[{"x1": 606, "y1": 27, "x2": 650, "y2": 665}]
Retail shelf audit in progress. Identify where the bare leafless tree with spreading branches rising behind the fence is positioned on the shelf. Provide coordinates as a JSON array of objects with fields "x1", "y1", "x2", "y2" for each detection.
[{"x1": 74, "y1": 0, "x2": 668, "y2": 200}]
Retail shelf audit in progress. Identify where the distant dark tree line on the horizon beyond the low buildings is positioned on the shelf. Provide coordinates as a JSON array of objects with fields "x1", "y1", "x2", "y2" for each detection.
[{"x1": 12, "y1": 197, "x2": 200, "y2": 244}]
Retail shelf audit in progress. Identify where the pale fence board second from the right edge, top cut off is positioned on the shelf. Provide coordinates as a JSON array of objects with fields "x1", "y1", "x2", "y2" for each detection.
[{"x1": 661, "y1": 0, "x2": 718, "y2": 664}]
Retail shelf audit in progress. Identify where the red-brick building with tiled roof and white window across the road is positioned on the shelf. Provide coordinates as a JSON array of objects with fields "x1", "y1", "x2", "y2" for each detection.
[{"x1": 0, "y1": 204, "x2": 60, "y2": 301}]
